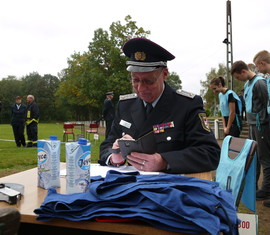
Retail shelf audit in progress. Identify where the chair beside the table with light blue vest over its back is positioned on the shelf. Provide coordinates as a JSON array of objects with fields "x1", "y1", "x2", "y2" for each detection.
[{"x1": 216, "y1": 136, "x2": 257, "y2": 212}]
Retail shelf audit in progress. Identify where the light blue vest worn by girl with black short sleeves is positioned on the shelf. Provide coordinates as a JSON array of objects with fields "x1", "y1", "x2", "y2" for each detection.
[{"x1": 218, "y1": 90, "x2": 242, "y2": 128}]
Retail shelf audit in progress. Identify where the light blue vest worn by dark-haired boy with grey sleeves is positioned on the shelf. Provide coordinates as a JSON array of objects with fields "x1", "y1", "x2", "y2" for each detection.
[{"x1": 244, "y1": 76, "x2": 265, "y2": 130}]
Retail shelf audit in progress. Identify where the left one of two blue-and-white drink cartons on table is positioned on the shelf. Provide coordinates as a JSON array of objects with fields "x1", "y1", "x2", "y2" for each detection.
[{"x1": 37, "y1": 136, "x2": 61, "y2": 189}]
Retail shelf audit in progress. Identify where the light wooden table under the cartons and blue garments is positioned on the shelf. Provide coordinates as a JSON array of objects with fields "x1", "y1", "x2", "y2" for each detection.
[{"x1": 0, "y1": 163, "x2": 209, "y2": 235}]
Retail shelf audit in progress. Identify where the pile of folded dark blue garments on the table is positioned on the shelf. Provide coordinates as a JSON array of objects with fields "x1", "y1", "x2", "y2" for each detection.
[{"x1": 34, "y1": 170, "x2": 239, "y2": 234}]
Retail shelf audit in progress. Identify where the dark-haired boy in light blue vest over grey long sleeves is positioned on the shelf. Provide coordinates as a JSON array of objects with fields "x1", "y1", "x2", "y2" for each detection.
[{"x1": 231, "y1": 61, "x2": 270, "y2": 200}]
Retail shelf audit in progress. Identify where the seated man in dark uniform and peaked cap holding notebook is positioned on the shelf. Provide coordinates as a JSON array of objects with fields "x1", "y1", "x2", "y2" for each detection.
[{"x1": 99, "y1": 38, "x2": 220, "y2": 174}]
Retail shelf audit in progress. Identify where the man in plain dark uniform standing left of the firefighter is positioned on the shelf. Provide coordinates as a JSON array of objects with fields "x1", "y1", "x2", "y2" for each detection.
[{"x1": 11, "y1": 96, "x2": 26, "y2": 147}]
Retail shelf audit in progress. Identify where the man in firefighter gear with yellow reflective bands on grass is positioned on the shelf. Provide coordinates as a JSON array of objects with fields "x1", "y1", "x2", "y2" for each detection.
[{"x1": 26, "y1": 95, "x2": 39, "y2": 147}]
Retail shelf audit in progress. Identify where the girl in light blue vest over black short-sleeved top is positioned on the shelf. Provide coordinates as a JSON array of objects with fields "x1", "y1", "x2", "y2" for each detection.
[{"x1": 210, "y1": 77, "x2": 242, "y2": 137}]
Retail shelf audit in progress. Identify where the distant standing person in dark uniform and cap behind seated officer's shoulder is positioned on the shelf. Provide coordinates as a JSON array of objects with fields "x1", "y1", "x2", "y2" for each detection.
[{"x1": 102, "y1": 91, "x2": 115, "y2": 138}]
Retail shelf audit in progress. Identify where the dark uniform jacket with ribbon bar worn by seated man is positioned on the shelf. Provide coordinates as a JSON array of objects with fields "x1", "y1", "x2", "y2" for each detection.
[{"x1": 100, "y1": 83, "x2": 220, "y2": 173}]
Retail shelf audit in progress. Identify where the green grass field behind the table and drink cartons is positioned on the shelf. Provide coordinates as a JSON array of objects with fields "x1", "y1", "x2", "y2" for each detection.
[{"x1": 0, "y1": 123, "x2": 104, "y2": 177}]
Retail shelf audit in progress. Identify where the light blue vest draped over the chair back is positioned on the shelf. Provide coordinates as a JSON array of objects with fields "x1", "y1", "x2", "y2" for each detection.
[{"x1": 216, "y1": 135, "x2": 256, "y2": 211}]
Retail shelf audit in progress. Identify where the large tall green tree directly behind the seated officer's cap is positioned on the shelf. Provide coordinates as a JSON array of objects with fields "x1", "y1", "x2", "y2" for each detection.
[{"x1": 56, "y1": 16, "x2": 184, "y2": 120}]
